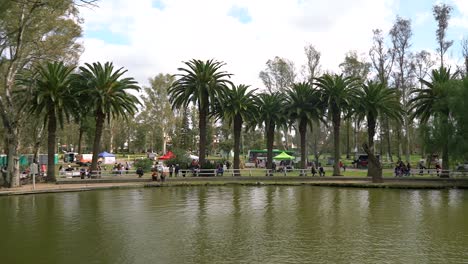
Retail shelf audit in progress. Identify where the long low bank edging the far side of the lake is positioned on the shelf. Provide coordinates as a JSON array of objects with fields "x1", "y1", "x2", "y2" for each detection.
[{"x1": 0, "y1": 177, "x2": 468, "y2": 196}]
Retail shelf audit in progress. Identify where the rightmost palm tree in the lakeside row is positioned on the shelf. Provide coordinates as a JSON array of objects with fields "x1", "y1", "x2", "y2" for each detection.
[{"x1": 408, "y1": 67, "x2": 456, "y2": 173}]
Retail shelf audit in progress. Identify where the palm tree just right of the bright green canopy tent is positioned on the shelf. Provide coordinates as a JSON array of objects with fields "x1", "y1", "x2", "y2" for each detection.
[{"x1": 286, "y1": 82, "x2": 324, "y2": 173}]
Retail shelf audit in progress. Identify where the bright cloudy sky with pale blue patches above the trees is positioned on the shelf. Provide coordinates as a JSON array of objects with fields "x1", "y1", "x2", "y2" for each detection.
[{"x1": 79, "y1": 0, "x2": 468, "y2": 88}]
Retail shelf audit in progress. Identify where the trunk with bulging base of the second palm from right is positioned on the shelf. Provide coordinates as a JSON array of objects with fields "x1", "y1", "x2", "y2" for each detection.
[{"x1": 363, "y1": 114, "x2": 383, "y2": 183}]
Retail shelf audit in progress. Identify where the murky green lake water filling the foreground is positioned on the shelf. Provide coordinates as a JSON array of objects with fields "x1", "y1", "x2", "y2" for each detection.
[{"x1": 0, "y1": 186, "x2": 468, "y2": 264}]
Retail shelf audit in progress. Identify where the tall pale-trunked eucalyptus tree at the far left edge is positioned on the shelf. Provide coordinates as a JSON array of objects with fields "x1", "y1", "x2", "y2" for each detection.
[{"x1": 0, "y1": 0, "x2": 82, "y2": 187}]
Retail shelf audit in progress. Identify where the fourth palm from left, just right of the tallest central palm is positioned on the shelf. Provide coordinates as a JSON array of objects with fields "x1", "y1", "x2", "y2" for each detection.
[{"x1": 215, "y1": 84, "x2": 256, "y2": 176}]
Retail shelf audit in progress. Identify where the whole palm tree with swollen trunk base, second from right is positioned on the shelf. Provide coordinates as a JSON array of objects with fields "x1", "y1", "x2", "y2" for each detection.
[{"x1": 355, "y1": 81, "x2": 404, "y2": 183}]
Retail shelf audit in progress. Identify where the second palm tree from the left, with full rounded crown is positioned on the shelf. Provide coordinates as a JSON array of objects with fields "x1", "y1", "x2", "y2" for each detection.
[{"x1": 74, "y1": 62, "x2": 140, "y2": 171}]
